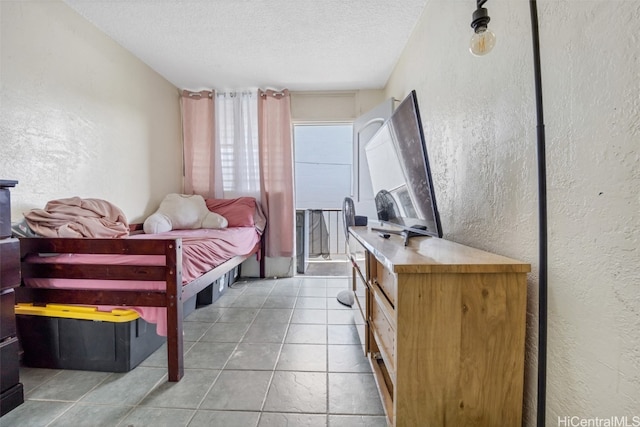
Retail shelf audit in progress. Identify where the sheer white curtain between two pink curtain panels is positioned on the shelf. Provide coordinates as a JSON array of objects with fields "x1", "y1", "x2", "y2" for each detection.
[{"x1": 215, "y1": 91, "x2": 260, "y2": 201}]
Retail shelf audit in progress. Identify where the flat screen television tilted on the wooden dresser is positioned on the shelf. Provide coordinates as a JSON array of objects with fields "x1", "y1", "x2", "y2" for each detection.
[{"x1": 365, "y1": 90, "x2": 442, "y2": 244}]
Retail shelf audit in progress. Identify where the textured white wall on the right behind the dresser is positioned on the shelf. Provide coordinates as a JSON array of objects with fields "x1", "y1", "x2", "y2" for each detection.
[{"x1": 386, "y1": 0, "x2": 640, "y2": 425}]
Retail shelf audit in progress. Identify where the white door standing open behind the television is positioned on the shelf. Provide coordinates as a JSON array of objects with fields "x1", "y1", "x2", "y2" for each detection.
[{"x1": 351, "y1": 98, "x2": 394, "y2": 220}]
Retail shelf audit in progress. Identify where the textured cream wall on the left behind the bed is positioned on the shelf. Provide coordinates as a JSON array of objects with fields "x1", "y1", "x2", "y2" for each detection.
[{"x1": 0, "y1": 1, "x2": 182, "y2": 222}]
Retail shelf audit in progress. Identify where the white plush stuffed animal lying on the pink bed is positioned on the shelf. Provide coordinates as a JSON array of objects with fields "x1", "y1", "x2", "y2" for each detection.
[{"x1": 143, "y1": 193, "x2": 228, "y2": 234}]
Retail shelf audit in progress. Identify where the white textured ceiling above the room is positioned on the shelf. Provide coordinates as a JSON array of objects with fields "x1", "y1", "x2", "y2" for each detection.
[{"x1": 64, "y1": 0, "x2": 428, "y2": 91}]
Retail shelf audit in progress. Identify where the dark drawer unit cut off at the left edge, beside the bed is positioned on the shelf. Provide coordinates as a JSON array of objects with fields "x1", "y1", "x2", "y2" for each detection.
[{"x1": 0, "y1": 180, "x2": 24, "y2": 416}]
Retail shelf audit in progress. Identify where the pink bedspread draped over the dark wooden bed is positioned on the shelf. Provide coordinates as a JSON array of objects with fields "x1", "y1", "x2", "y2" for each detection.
[{"x1": 25, "y1": 227, "x2": 260, "y2": 336}]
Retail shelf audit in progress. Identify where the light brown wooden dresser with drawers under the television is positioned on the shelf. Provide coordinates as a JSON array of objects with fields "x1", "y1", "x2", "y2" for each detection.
[{"x1": 349, "y1": 227, "x2": 531, "y2": 427}]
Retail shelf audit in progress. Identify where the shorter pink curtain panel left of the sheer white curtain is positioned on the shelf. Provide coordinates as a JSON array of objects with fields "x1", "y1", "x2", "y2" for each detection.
[{"x1": 181, "y1": 91, "x2": 222, "y2": 197}]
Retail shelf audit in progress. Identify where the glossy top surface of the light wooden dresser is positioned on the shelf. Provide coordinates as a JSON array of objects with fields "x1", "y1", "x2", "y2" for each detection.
[{"x1": 350, "y1": 227, "x2": 531, "y2": 273}]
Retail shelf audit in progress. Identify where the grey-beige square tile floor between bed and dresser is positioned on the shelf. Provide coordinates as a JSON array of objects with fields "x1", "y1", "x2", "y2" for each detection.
[{"x1": 0, "y1": 276, "x2": 387, "y2": 427}]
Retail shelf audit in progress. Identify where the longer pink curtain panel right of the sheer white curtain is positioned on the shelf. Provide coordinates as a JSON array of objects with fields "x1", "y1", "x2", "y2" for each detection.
[{"x1": 258, "y1": 90, "x2": 295, "y2": 257}]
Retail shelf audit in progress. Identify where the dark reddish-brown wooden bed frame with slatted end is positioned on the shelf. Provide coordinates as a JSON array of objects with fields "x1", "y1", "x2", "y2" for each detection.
[{"x1": 15, "y1": 232, "x2": 265, "y2": 382}]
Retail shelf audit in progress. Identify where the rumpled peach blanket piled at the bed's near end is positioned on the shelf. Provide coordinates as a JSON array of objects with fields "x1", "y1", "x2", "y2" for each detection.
[{"x1": 24, "y1": 197, "x2": 129, "y2": 238}]
